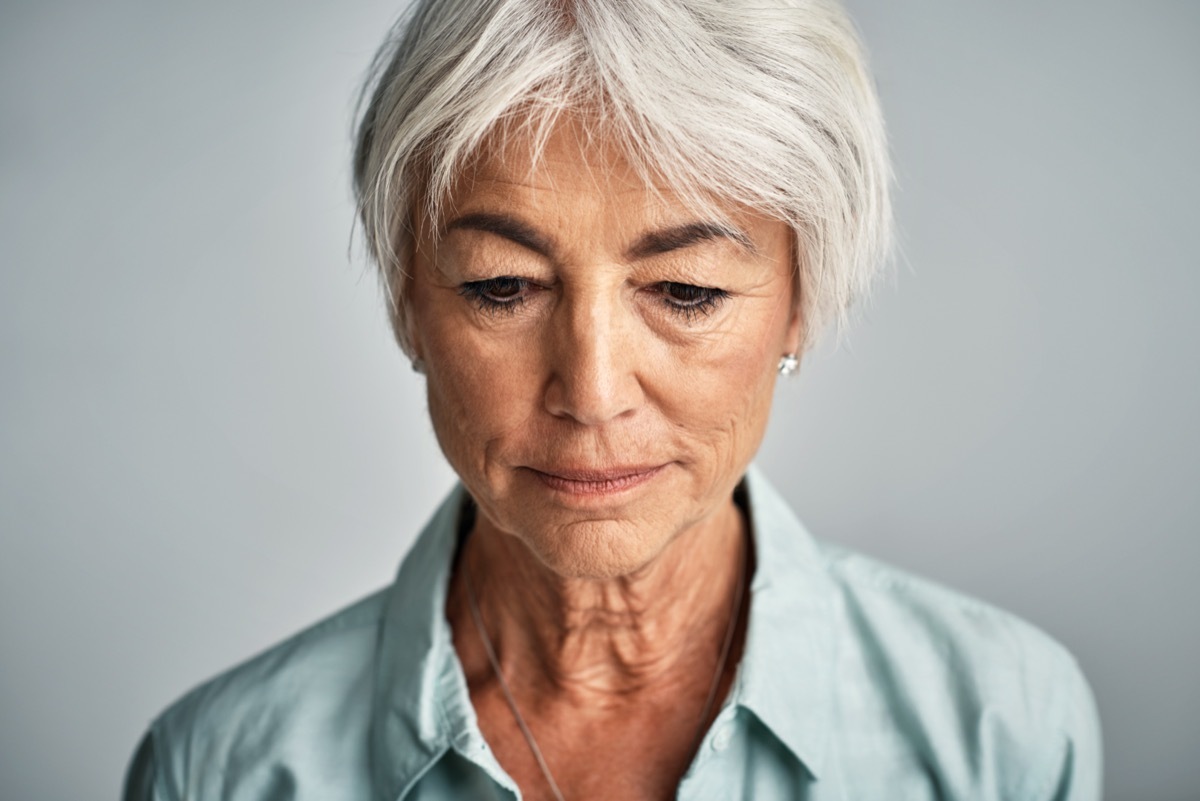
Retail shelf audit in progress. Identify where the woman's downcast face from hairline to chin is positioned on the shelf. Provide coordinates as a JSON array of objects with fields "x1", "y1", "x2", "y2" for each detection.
[{"x1": 407, "y1": 115, "x2": 800, "y2": 578}]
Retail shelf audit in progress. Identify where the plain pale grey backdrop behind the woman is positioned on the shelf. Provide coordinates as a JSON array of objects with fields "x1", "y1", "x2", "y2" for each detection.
[{"x1": 0, "y1": 0, "x2": 1200, "y2": 801}]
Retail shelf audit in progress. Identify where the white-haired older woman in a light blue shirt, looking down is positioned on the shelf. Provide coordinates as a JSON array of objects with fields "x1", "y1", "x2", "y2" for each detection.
[{"x1": 126, "y1": 0, "x2": 1099, "y2": 801}]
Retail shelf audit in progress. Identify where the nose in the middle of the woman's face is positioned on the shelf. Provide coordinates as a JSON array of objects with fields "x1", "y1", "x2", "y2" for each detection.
[{"x1": 545, "y1": 291, "x2": 646, "y2": 426}]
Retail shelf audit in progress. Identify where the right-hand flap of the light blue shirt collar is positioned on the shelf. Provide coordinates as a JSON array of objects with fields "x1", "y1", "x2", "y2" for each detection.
[{"x1": 734, "y1": 466, "x2": 838, "y2": 778}]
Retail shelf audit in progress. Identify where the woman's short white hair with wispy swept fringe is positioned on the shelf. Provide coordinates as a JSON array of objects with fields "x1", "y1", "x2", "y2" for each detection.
[{"x1": 354, "y1": 0, "x2": 892, "y2": 353}]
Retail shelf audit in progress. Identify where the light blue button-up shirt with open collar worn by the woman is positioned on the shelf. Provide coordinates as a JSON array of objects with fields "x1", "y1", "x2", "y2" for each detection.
[{"x1": 126, "y1": 469, "x2": 1100, "y2": 801}]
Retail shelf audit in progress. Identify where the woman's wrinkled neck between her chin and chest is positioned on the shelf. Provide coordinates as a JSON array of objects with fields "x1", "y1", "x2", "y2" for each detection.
[{"x1": 448, "y1": 500, "x2": 746, "y2": 707}]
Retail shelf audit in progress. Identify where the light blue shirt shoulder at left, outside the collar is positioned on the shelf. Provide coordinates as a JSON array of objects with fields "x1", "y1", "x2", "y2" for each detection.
[{"x1": 138, "y1": 590, "x2": 386, "y2": 800}]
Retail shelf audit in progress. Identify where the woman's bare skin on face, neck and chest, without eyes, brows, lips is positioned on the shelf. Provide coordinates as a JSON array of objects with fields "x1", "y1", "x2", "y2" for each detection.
[{"x1": 406, "y1": 118, "x2": 800, "y2": 799}]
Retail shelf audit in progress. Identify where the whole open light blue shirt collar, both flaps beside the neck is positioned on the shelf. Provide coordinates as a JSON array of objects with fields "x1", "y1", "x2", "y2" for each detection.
[{"x1": 371, "y1": 466, "x2": 836, "y2": 800}]
